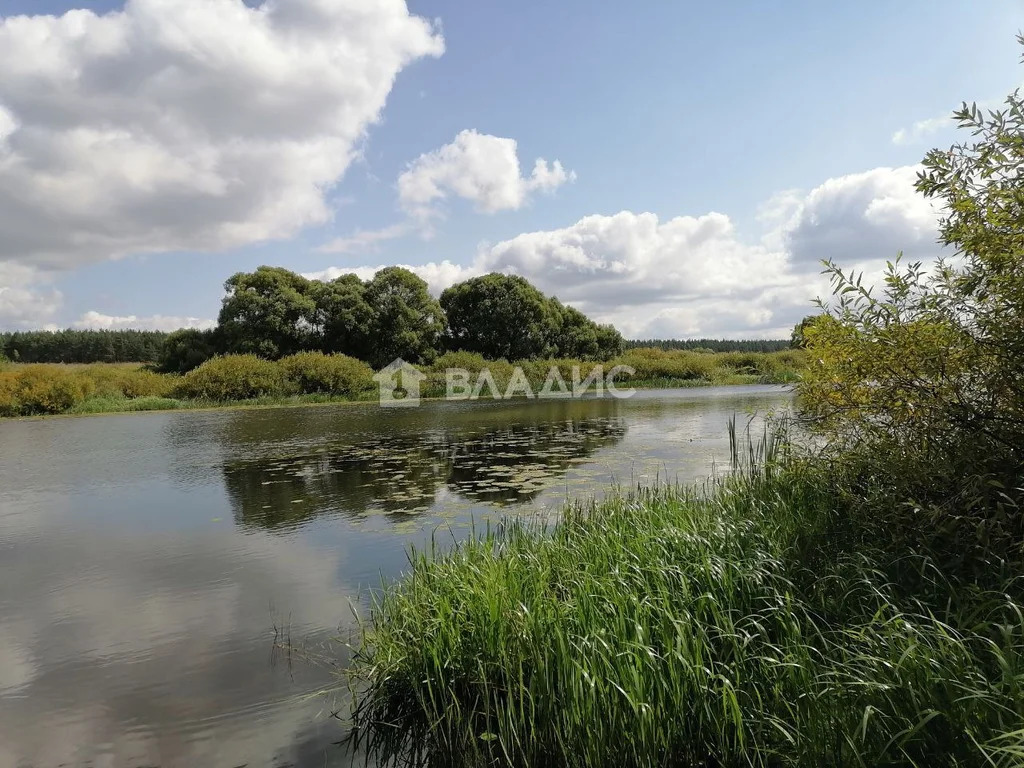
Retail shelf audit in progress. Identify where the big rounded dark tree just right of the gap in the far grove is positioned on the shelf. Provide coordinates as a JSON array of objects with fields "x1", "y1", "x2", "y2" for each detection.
[{"x1": 440, "y1": 272, "x2": 550, "y2": 360}]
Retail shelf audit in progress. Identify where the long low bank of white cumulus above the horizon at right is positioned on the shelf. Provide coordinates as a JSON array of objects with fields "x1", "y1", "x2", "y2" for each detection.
[{"x1": 317, "y1": 166, "x2": 939, "y2": 338}]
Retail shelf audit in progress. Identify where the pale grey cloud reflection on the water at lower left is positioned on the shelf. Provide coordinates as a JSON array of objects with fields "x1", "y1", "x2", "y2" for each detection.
[{"x1": 0, "y1": 530, "x2": 364, "y2": 766}]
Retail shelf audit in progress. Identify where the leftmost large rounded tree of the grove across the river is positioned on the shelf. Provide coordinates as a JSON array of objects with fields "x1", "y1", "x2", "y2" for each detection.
[{"x1": 212, "y1": 266, "x2": 317, "y2": 358}]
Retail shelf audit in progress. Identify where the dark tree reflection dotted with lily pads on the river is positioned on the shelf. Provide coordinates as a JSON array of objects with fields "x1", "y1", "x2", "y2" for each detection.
[{"x1": 223, "y1": 417, "x2": 627, "y2": 528}]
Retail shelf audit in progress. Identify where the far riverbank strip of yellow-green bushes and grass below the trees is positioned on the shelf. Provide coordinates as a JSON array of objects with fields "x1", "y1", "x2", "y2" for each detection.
[{"x1": 0, "y1": 349, "x2": 805, "y2": 418}]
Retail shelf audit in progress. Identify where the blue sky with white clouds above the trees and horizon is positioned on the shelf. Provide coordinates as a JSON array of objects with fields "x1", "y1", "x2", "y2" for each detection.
[{"x1": 0, "y1": 0, "x2": 1024, "y2": 338}]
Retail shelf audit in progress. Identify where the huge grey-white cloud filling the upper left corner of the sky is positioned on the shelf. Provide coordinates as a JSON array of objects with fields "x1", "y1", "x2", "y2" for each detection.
[{"x1": 0, "y1": 0, "x2": 443, "y2": 269}]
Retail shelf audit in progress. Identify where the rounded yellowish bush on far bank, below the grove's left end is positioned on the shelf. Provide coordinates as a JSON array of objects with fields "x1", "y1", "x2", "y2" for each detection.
[{"x1": 175, "y1": 354, "x2": 288, "y2": 400}]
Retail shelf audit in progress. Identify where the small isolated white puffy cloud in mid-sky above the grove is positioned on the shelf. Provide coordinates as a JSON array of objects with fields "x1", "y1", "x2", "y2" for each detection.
[{"x1": 398, "y1": 130, "x2": 575, "y2": 218}]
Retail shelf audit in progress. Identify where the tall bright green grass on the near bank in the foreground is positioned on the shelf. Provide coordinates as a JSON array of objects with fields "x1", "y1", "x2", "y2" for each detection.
[{"x1": 351, "y1": 435, "x2": 1024, "y2": 767}]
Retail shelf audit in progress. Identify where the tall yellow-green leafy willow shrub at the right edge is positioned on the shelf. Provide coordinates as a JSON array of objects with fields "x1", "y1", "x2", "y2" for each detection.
[{"x1": 800, "y1": 60, "x2": 1024, "y2": 579}]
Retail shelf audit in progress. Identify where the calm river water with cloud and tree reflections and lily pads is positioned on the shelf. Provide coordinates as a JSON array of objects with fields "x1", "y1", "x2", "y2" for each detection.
[{"x1": 0, "y1": 387, "x2": 790, "y2": 768}]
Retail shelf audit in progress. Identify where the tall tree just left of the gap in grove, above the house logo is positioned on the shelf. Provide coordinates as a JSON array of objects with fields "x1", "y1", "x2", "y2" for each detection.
[{"x1": 366, "y1": 266, "x2": 444, "y2": 368}]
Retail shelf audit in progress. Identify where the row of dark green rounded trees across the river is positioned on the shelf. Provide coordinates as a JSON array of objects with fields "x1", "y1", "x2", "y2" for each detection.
[{"x1": 160, "y1": 266, "x2": 624, "y2": 373}]
